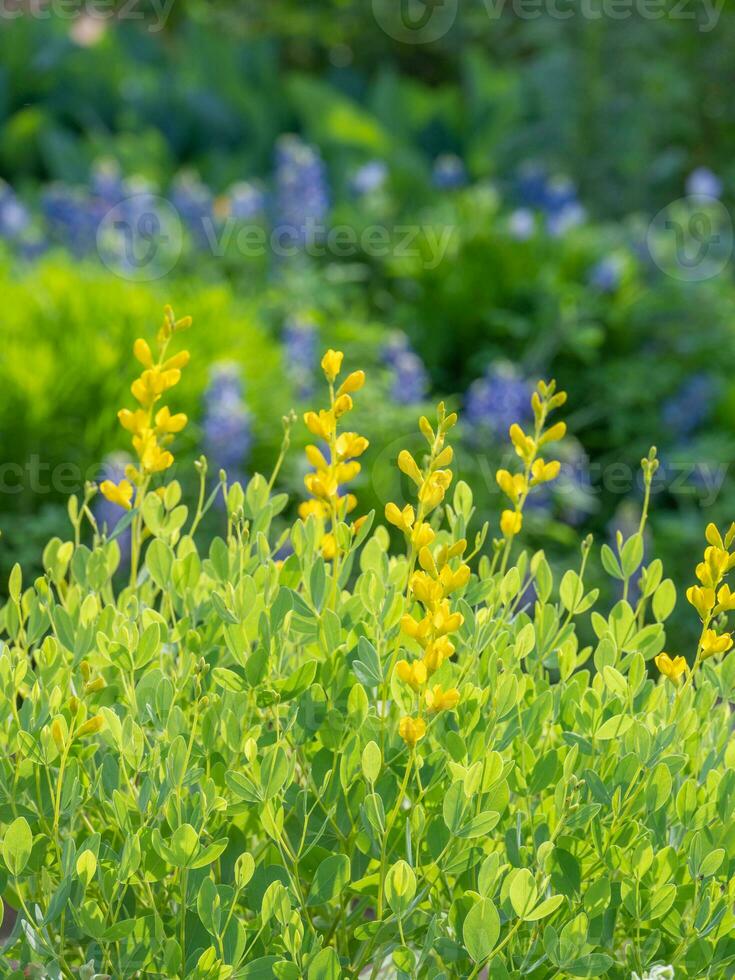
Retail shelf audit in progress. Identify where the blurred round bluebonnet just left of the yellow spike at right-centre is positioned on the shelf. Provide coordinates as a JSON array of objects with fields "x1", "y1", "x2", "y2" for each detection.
[{"x1": 464, "y1": 361, "x2": 533, "y2": 438}]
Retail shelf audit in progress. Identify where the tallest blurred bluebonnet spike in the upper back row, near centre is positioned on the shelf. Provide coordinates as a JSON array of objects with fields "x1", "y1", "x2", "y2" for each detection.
[{"x1": 275, "y1": 135, "x2": 329, "y2": 248}]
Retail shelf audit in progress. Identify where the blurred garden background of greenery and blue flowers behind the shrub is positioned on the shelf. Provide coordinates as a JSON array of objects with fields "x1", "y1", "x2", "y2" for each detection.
[{"x1": 0, "y1": 0, "x2": 735, "y2": 644}]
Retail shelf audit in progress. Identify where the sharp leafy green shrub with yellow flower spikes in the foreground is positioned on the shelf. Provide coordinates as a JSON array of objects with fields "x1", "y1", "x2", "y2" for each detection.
[{"x1": 0, "y1": 319, "x2": 735, "y2": 980}]
